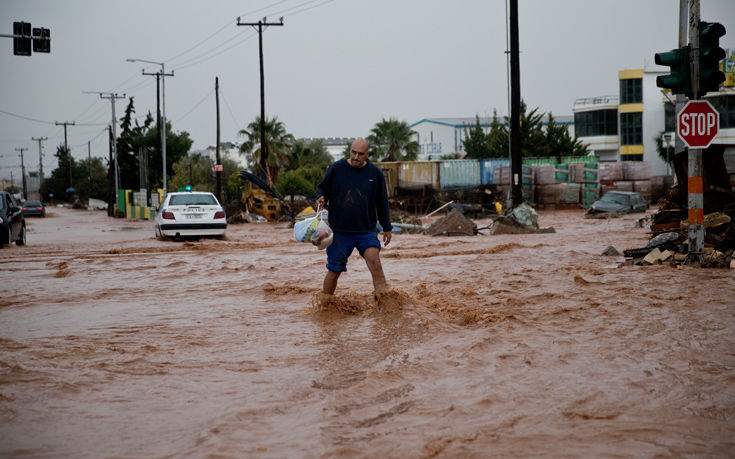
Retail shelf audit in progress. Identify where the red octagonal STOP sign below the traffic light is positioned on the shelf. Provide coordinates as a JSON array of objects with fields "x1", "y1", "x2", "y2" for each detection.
[{"x1": 676, "y1": 100, "x2": 720, "y2": 148}]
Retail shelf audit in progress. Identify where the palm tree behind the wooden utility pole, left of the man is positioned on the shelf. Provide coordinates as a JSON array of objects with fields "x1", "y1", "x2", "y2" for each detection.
[{"x1": 238, "y1": 116, "x2": 294, "y2": 187}]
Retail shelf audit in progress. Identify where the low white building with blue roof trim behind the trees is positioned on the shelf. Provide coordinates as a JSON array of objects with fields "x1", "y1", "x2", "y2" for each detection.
[{"x1": 409, "y1": 116, "x2": 573, "y2": 161}]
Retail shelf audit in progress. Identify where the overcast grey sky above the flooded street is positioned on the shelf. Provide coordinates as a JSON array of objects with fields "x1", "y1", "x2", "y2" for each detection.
[{"x1": 0, "y1": 0, "x2": 735, "y2": 178}]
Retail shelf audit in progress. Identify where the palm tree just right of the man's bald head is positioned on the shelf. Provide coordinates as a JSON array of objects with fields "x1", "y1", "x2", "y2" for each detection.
[{"x1": 367, "y1": 118, "x2": 420, "y2": 161}]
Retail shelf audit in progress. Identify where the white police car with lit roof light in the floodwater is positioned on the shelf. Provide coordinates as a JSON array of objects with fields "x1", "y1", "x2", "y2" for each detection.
[{"x1": 155, "y1": 191, "x2": 227, "y2": 239}]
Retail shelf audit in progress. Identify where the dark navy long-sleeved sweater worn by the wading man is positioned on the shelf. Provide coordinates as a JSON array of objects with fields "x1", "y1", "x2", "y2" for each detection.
[{"x1": 316, "y1": 159, "x2": 393, "y2": 233}]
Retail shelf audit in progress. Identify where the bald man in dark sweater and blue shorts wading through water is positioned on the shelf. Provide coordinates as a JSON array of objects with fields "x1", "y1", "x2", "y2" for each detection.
[{"x1": 316, "y1": 139, "x2": 393, "y2": 298}]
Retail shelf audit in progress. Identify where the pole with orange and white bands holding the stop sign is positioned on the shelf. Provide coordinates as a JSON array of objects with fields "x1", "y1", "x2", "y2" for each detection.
[{"x1": 687, "y1": 0, "x2": 704, "y2": 264}]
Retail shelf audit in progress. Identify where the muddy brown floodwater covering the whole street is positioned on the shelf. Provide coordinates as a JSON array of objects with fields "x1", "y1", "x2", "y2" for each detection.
[{"x1": 0, "y1": 208, "x2": 735, "y2": 458}]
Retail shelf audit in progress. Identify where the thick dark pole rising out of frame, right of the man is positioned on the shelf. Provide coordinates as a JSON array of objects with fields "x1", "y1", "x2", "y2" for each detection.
[{"x1": 510, "y1": 0, "x2": 523, "y2": 207}]
